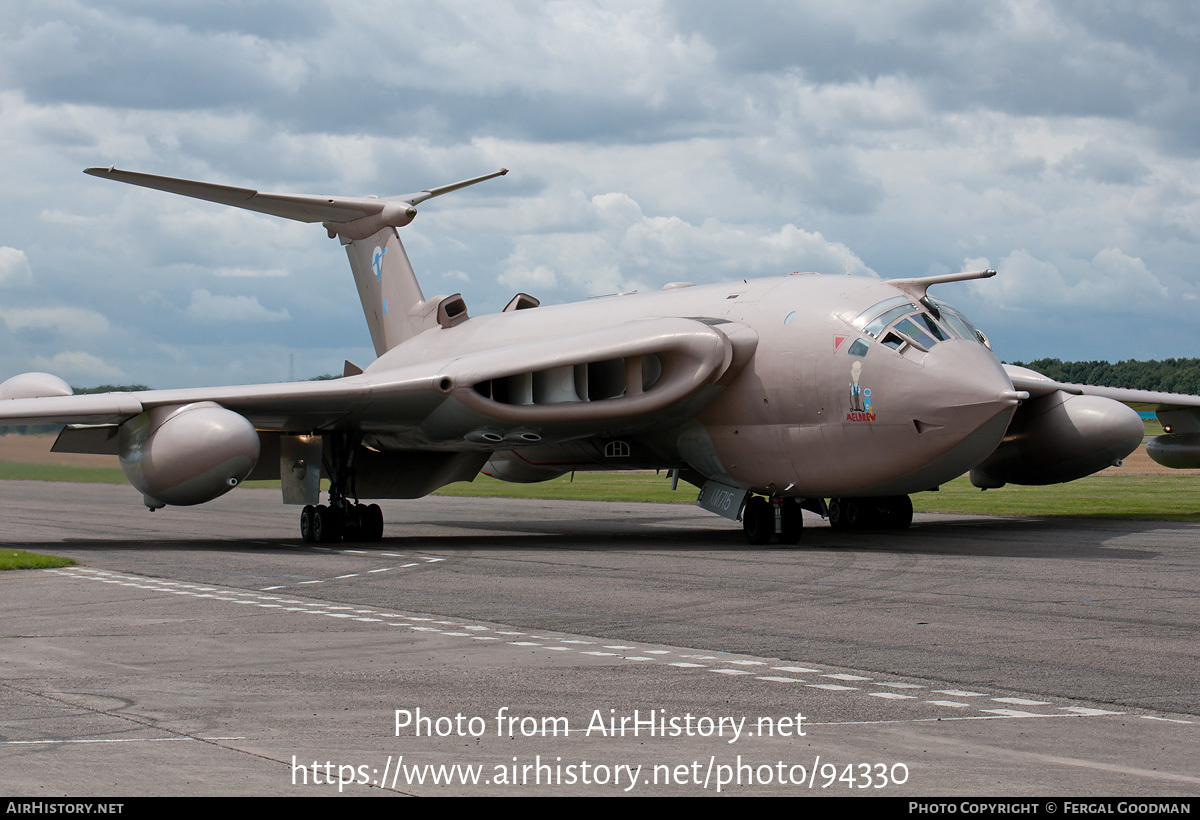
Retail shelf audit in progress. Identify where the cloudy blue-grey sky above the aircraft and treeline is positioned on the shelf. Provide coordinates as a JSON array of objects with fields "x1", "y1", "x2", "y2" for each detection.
[{"x1": 0, "y1": 0, "x2": 1200, "y2": 388}]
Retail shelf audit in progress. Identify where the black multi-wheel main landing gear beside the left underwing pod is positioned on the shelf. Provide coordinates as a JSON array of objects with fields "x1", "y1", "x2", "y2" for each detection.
[{"x1": 300, "y1": 433, "x2": 383, "y2": 544}]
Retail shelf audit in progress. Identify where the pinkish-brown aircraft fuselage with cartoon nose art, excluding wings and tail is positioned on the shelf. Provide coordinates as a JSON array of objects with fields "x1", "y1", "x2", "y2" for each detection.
[{"x1": 366, "y1": 274, "x2": 1018, "y2": 497}]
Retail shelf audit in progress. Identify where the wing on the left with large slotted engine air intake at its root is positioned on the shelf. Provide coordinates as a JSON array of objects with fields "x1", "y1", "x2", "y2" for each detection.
[{"x1": 0, "y1": 318, "x2": 757, "y2": 441}]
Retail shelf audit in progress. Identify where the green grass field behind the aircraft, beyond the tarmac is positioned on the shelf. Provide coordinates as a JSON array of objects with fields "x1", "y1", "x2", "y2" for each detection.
[{"x1": 0, "y1": 421, "x2": 1200, "y2": 521}]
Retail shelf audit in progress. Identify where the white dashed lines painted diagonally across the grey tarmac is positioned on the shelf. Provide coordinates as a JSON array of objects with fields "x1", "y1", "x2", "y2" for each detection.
[{"x1": 44, "y1": 571, "x2": 1193, "y2": 725}]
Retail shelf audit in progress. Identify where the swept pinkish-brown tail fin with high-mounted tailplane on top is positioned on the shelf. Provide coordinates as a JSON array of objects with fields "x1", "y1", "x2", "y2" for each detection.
[{"x1": 84, "y1": 166, "x2": 509, "y2": 355}]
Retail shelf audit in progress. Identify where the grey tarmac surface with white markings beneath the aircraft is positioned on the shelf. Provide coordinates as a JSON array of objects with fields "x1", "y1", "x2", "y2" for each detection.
[{"x1": 0, "y1": 481, "x2": 1200, "y2": 798}]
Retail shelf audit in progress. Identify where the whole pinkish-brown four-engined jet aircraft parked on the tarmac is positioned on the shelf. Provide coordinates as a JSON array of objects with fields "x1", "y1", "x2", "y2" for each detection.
[{"x1": 0, "y1": 167, "x2": 1200, "y2": 544}]
